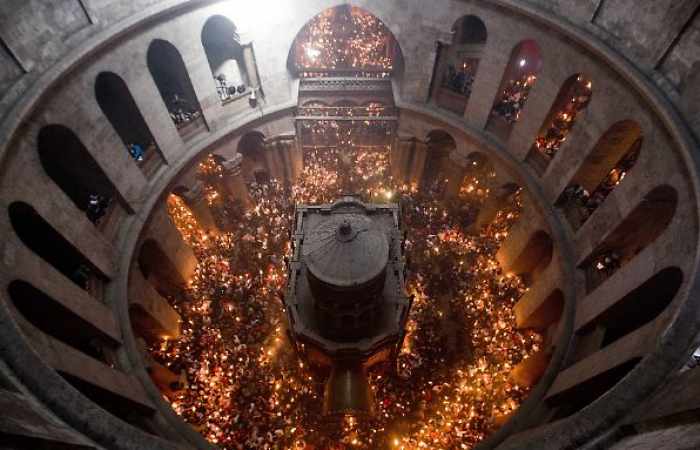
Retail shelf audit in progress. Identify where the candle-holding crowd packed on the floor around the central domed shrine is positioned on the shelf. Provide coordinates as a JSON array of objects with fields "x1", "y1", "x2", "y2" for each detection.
[{"x1": 150, "y1": 147, "x2": 541, "y2": 450}]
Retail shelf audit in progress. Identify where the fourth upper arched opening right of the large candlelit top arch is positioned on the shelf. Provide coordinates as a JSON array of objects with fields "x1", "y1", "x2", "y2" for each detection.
[{"x1": 556, "y1": 120, "x2": 643, "y2": 230}]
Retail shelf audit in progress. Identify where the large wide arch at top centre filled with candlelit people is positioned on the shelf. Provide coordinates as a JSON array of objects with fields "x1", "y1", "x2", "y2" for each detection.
[{"x1": 289, "y1": 5, "x2": 401, "y2": 78}]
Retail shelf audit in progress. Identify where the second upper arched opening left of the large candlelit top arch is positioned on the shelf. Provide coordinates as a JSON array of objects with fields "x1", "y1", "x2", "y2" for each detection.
[{"x1": 147, "y1": 39, "x2": 206, "y2": 139}]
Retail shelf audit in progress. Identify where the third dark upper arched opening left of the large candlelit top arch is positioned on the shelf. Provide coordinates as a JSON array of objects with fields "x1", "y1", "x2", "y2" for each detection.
[{"x1": 95, "y1": 72, "x2": 164, "y2": 175}]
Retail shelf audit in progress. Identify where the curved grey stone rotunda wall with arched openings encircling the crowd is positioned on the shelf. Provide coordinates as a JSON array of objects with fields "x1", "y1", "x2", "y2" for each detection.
[{"x1": 0, "y1": 0, "x2": 700, "y2": 449}]
